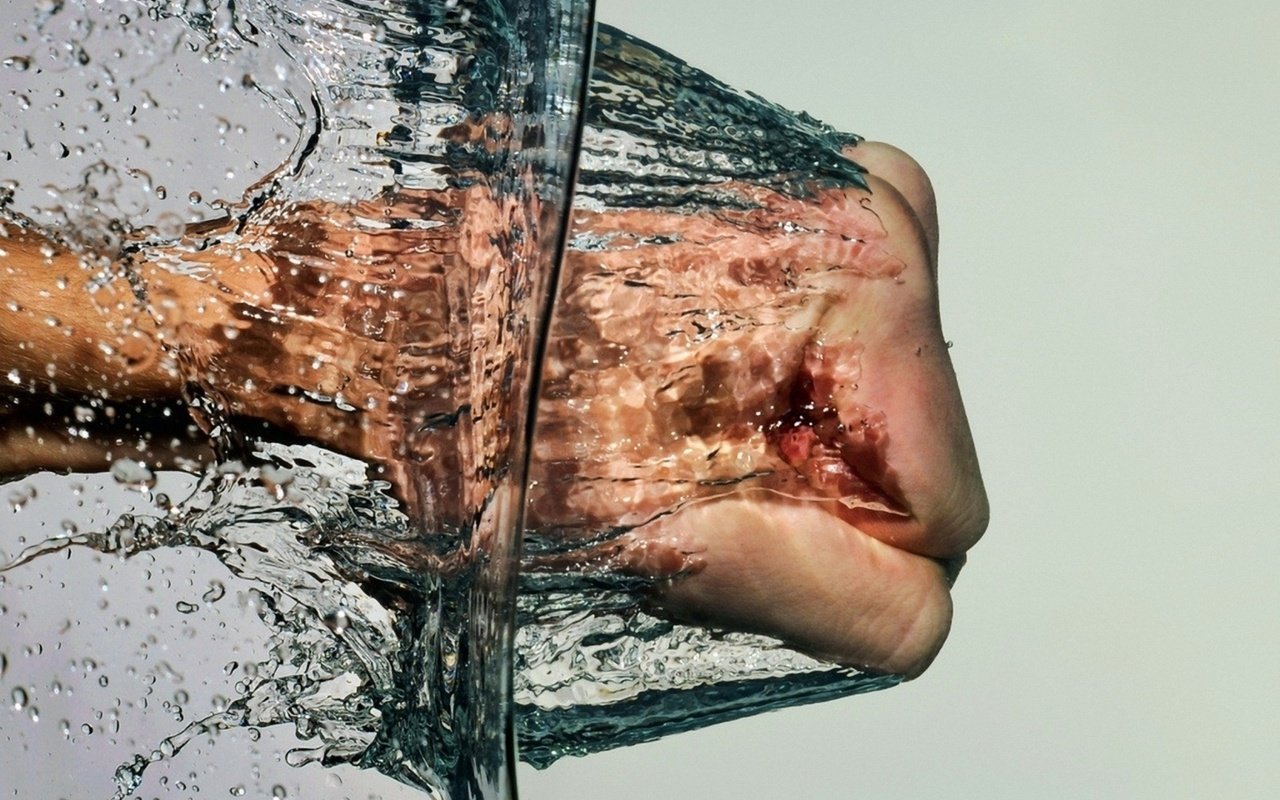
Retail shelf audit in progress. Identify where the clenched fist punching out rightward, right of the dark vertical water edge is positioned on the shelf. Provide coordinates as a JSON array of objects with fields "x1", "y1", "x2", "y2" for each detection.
[{"x1": 531, "y1": 143, "x2": 988, "y2": 676}]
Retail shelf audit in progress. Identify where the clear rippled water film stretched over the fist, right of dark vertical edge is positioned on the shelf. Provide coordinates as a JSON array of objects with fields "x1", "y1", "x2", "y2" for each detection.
[{"x1": 516, "y1": 26, "x2": 905, "y2": 765}]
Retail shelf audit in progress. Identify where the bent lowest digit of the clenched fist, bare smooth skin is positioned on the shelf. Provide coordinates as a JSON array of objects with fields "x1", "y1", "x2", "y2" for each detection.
[{"x1": 635, "y1": 494, "x2": 951, "y2": 677}]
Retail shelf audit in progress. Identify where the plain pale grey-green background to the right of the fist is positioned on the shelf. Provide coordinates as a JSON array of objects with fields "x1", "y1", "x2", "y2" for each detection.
[{"x1": 521, "y1": 0, "x2": 1280, "y2": 800}]
